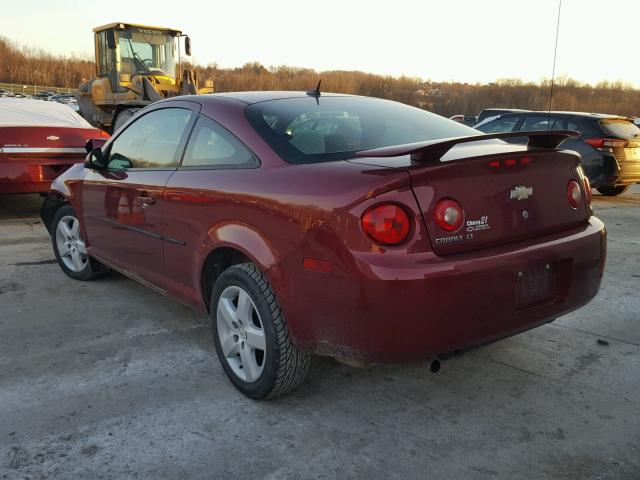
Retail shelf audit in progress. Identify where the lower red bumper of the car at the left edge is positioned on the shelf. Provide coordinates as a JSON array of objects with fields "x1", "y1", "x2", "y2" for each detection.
[{"x1": 0, "y1": 158, "x2": 81, "y2": 193}]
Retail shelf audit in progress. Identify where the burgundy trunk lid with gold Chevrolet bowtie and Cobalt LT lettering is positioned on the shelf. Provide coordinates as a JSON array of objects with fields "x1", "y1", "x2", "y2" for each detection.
[{"x1": 356, "y1": 142, "x2": 591, "y2": 255}]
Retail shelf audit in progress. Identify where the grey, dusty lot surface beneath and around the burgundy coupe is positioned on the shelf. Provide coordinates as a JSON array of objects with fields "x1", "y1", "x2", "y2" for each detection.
[{"x1": 0, "y1": 186, "x2": 640, "y2": 480}]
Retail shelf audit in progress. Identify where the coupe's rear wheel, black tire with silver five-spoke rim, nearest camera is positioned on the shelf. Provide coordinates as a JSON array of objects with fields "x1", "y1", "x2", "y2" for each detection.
[{"x1": 211, "y1": 263, "x2": 311, "y2": 400}]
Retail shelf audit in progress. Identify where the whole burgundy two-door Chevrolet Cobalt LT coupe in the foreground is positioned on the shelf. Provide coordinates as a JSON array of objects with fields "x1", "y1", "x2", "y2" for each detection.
[{"x1": 42, "y1": 92, "x2": 606, "y2": 398}]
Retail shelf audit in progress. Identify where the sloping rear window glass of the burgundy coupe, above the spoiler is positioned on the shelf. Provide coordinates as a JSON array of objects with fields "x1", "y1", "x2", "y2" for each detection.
[{"x1": 246, "y1": 96, "x2": 481, "y2": 163}]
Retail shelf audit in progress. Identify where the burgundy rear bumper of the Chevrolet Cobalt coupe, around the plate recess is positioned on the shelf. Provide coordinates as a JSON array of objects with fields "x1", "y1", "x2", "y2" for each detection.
[{"x1": 276, "y1": 217, "x2": 606, "y2": 362}]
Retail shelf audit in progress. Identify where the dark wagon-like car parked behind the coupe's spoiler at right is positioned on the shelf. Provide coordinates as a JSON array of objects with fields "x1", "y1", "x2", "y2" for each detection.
[{"x1": 474, "y1": 112, "x2": 640, "y2": 195}]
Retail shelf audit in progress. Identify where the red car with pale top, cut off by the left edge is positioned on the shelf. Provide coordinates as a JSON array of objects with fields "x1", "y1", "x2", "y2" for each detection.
[{"x1": 0, "y1": 98, "x2": 109, "y2": 193}]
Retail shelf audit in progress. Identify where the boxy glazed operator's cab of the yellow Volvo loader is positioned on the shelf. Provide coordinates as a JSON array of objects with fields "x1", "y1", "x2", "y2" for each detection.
[{"x1": 94, "y1": 23, "x2": 191, "y2": 92}]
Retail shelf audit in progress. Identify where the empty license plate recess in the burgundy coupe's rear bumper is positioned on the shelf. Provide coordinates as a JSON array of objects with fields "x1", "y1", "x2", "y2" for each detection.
[{"x1": 515, "y1": 263, "x2": 558, "y2": 310}]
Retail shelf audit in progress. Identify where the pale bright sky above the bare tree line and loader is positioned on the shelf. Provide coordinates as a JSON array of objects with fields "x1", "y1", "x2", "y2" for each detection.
[{"x1": 0, "y1": 0, "x2": 640, "y2": 86}]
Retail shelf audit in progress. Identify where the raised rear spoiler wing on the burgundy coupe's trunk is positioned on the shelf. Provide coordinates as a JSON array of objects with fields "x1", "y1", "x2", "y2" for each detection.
[{"x1": 356, "y1": 130, "x2": 580, "y2": 162}]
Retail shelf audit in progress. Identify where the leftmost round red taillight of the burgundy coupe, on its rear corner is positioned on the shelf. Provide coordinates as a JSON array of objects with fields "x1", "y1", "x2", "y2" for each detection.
[{"x1": 361, "y1": 203, "x2": 411, "y2": 245}]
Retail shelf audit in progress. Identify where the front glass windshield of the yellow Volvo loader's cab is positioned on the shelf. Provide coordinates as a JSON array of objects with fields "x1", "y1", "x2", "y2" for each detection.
[{"x1": 118, "y1": 28, "x2": 176, "y2": 78}]
